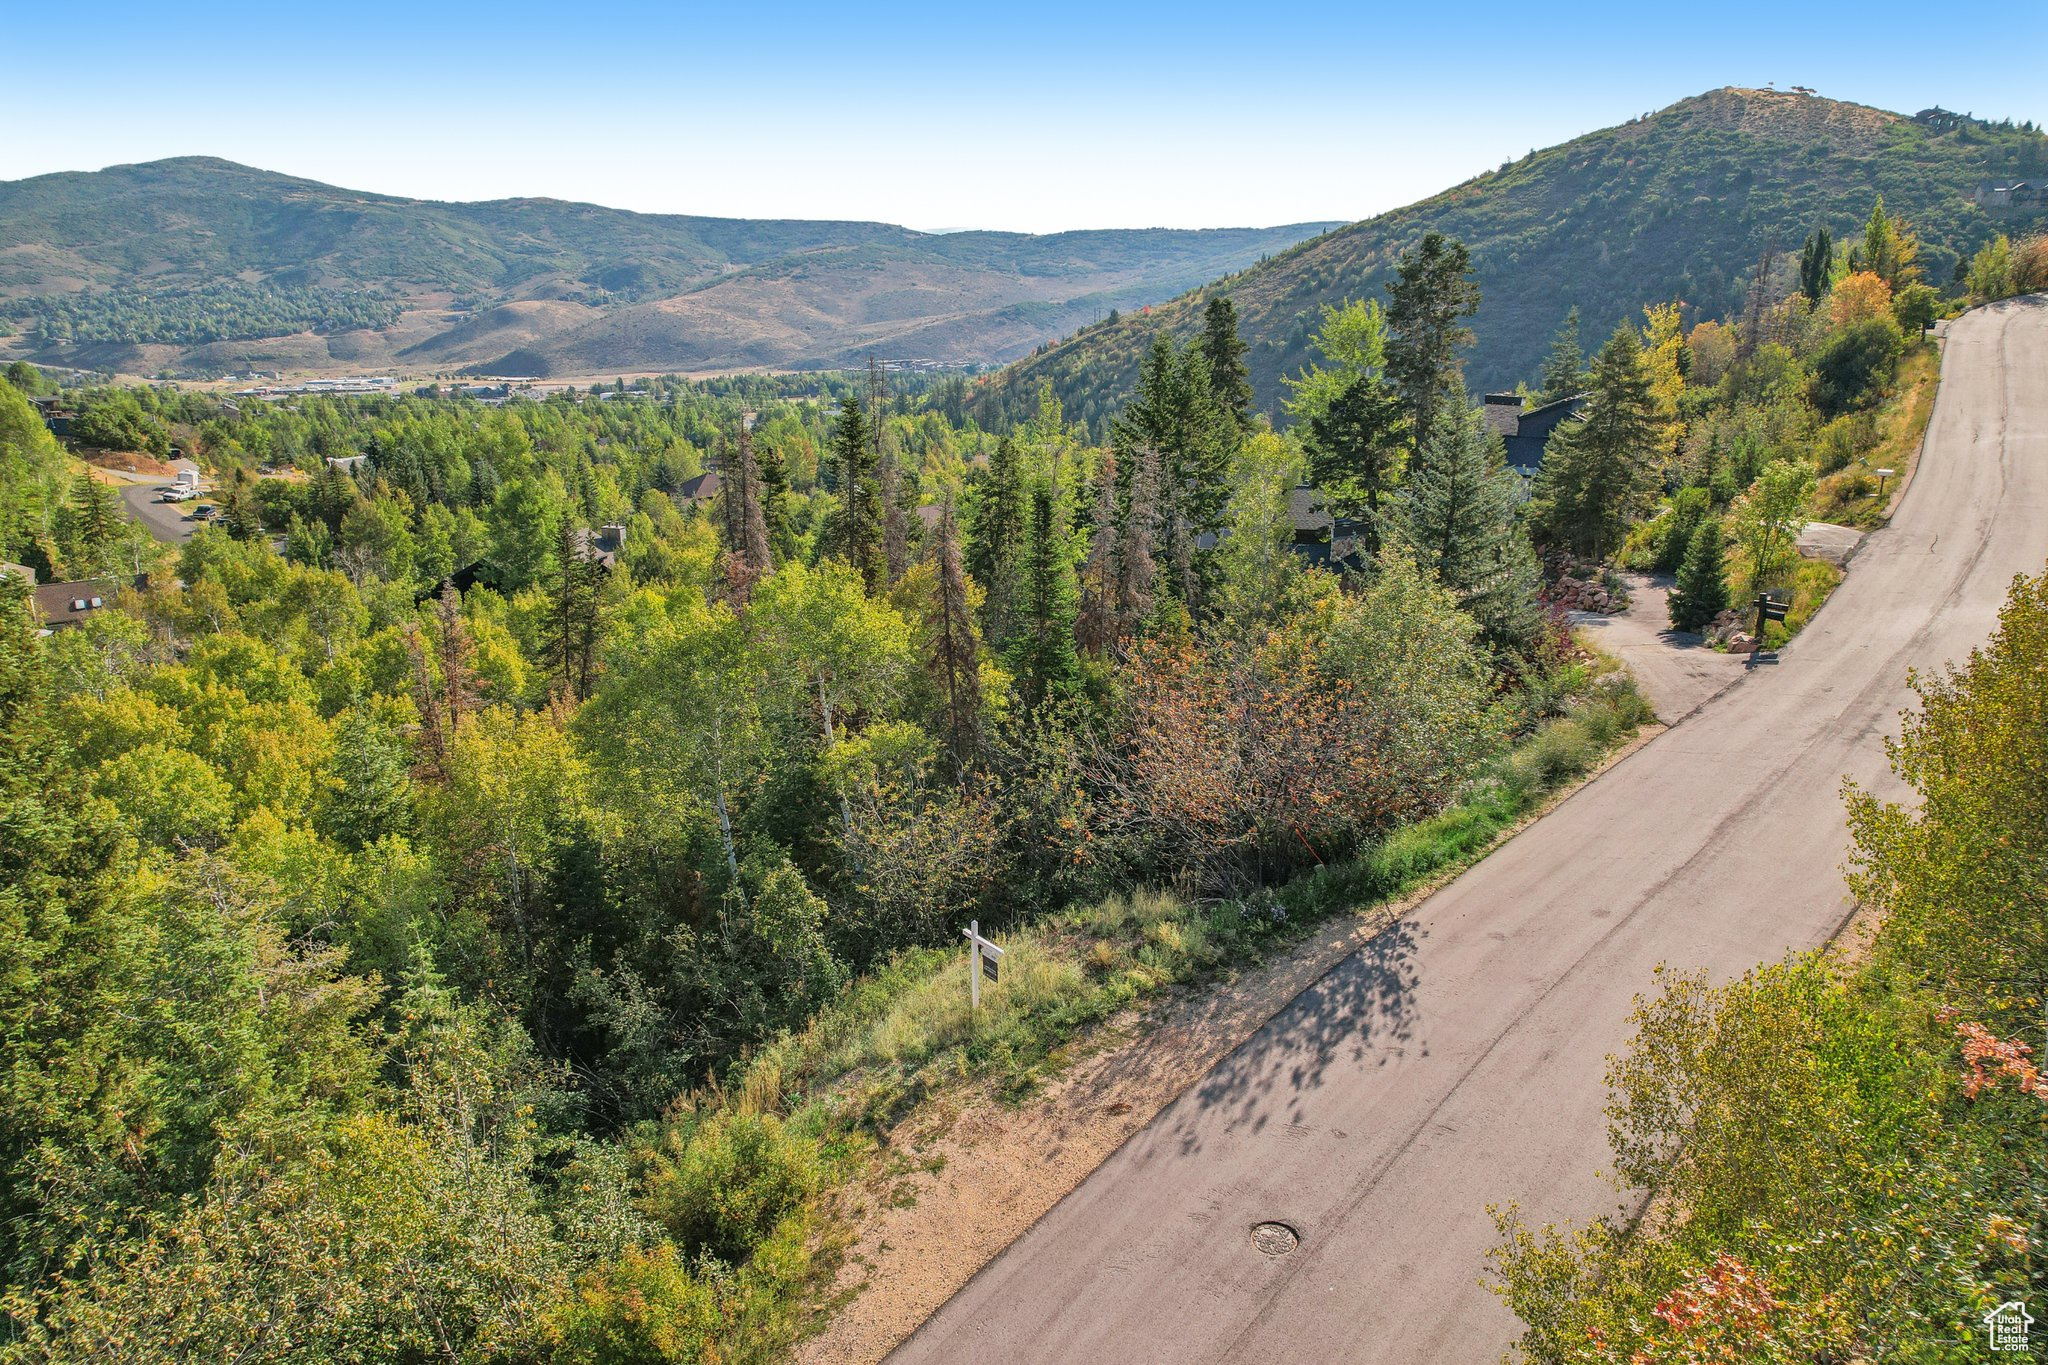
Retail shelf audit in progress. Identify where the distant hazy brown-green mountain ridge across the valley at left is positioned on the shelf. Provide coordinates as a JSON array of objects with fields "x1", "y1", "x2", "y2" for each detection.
[{"x1": 0, "y1": 158, "x2": 1331, "y2": 384}]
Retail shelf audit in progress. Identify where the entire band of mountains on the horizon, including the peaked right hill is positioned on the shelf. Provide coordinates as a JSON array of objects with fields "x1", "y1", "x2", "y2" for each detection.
[{"x1": 0, "y1": 88, "x2": 2048, "y2": 397}]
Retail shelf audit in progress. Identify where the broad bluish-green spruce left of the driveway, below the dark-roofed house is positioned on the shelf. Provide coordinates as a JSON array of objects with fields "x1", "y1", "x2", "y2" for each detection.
[{"x1": 1391, "y1": 395, "x2": 1540, "y2": 649}]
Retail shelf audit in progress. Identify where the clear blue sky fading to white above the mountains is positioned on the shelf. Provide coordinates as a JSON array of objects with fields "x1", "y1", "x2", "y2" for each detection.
[{"x1": 0, "y1": 0, "x2": 2048, "y2": 231}]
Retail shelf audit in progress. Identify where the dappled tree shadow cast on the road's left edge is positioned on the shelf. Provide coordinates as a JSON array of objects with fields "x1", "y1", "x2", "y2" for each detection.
[{"x1": 1167, "y1": 919, "x2": 1421, "y2": 1154}]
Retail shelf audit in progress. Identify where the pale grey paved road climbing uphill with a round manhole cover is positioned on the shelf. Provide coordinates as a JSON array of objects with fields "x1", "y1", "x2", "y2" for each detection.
[{"x1": 897, "y1": 299, "x2": 2048, "y2": 1365}]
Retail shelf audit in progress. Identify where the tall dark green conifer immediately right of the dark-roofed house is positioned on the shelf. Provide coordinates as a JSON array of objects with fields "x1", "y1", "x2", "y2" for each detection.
[{"x1": 1532, "y1": 321, "x2": 1663, "y2": 561}]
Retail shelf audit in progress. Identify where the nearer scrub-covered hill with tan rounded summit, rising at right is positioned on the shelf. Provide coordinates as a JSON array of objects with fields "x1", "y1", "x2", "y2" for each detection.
[{"x1": 983, "y1": 88, "x2": 2048, "y2": 430}]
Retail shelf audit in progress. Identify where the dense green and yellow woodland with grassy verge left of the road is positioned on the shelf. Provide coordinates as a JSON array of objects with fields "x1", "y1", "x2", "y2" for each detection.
[{"x1": 0, "y1": 173, "x2": 1998, "y2": 1365}]
